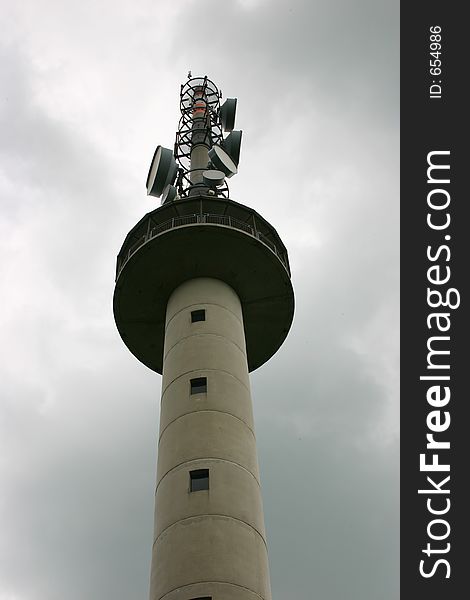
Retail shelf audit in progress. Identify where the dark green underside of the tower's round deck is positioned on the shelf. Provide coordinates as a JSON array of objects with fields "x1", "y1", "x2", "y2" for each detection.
[{"x1": 114, "y1": 224, "x2": 294, "y2": 373}]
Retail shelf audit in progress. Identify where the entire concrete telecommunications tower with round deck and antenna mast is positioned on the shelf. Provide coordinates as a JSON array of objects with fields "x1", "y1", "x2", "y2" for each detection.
[{"x1": 114, "y1": 77, "x2": 294, "y2": 600}]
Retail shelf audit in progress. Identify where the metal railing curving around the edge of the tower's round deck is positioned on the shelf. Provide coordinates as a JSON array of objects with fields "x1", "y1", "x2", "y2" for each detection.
[{"x1": 116, "y1": 213, "x2": 289, "y2": 279}]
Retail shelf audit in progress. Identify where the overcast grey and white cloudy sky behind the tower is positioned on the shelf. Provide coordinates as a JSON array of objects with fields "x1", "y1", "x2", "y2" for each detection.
[{"x1": 0, "y1": 0, "x2": 399, "y2": 600}]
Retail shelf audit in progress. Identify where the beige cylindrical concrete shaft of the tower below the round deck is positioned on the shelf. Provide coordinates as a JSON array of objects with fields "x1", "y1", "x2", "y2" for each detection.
[{"x1": 150, "y1": 278, "x2": 271, "y2": 600}]
